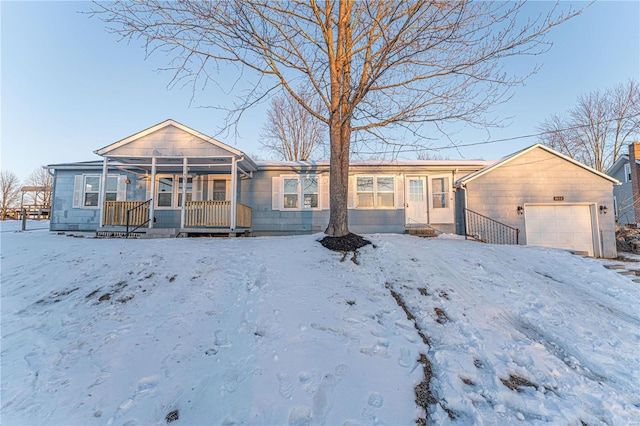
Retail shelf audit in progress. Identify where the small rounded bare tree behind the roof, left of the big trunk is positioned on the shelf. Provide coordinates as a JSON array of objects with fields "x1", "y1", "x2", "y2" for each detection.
[{"x1": 260, "y1": 88, "x2": 326, "y2": 161}]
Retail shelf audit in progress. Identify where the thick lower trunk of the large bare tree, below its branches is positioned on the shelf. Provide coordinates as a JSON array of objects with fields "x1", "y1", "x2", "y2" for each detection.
[{"x1": 324, "y1": 121, "x2": 351, "y2": 237}]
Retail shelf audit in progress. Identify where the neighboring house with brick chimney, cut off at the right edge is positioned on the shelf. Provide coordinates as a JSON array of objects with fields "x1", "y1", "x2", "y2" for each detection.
[{"x1": 607, "y1": 142, "x2": 640, "y2": 225}]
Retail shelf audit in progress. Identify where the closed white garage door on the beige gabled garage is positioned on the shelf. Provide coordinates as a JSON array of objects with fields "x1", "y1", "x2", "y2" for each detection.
[{"x1": 524, "y1": 205, "x2": 594, "y2": 256}]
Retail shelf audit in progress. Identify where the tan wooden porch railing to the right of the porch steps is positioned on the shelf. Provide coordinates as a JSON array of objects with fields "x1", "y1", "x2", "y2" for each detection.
[{"x1": 184, "y1": 201, "x2": 251, "y2": 228}]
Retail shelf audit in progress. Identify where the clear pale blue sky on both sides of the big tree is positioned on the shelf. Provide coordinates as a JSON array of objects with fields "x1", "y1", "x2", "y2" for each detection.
[{"x1": 0, "y1": 1, "x2": 640, "y2": 178}]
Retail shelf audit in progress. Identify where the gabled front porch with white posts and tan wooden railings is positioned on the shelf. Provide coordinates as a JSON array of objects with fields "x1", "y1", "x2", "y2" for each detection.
[{"x1": 90, "y1": 120, "x2": 257, "y2": 236}]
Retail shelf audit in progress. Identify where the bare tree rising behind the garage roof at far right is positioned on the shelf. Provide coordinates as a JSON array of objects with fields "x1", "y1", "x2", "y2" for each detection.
[{"x1": 538, "y1": 80, "x2": 640, "y2": 171}]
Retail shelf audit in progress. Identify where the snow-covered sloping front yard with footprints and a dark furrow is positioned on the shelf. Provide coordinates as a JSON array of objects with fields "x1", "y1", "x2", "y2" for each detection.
[{"x1": 0, "y1": 222, "x2": 640, "y2": 425}]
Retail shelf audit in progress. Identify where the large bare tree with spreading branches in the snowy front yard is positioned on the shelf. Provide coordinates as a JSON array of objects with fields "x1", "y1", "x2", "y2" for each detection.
[{"x1": 95, "y1": 0, "x2": 579, "y2": 236}]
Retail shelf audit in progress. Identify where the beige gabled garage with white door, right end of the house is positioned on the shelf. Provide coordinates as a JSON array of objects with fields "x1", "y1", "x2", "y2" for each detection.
[{"x1": 456, "y1": 144, "x2": 619, "y2": 258}]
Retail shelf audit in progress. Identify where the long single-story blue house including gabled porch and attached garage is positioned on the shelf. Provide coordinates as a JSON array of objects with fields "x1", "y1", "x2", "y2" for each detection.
[{"x1": 48, "y1": 120, "x2": 616, "y2": 257}]
